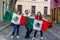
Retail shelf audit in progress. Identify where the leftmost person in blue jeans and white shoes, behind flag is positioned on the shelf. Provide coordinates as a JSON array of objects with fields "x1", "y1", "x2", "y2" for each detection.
[{"x1": 11, "y1": 11, "x2": 21, "y2": 38}]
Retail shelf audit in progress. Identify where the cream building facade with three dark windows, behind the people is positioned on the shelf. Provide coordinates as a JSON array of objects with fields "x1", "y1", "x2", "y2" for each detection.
[{"x1": 16, "y1": 0, "x2": 50, "y2": 15}]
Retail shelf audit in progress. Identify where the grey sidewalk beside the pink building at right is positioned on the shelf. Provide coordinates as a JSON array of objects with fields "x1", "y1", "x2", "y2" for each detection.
[{"x1": 49, "y1": 22, "x2": 60, "y2": 39}]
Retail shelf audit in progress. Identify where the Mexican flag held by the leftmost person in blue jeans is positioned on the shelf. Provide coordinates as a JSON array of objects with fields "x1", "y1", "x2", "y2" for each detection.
[{"x1": 3, "y1": 10, "x2": 26, "y2": 26}]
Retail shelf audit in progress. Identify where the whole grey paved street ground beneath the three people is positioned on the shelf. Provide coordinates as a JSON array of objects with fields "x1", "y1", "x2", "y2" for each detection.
[{"x1": 0, "y1": 17, "x2": 60, "y2": 40}]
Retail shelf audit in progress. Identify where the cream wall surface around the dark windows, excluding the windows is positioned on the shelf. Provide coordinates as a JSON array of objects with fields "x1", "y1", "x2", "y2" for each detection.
[{"x1": 16, "y1": 1, "x2": 50, "y2": 15}]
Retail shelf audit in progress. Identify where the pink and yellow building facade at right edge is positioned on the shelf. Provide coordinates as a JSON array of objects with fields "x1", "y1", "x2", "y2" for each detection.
[{"x1": 50, "y1": 0, "x2": 60, "y2": 23}]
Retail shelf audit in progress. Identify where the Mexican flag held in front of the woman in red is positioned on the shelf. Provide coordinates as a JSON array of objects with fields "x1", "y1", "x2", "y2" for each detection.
[{"x1": 25, "y1": 18, "x2": 50, "y2": 31}]
